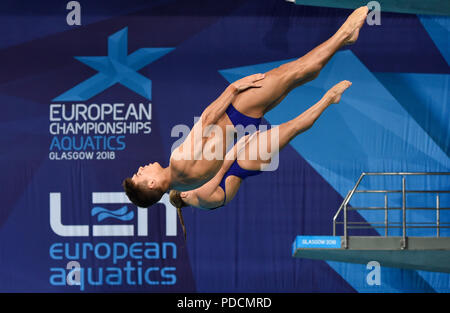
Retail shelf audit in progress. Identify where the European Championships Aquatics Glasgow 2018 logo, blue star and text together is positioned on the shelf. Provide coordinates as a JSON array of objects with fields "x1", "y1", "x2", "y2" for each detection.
[{"x1": 48, "y1": 27, "x2": 174, "y2": 161}]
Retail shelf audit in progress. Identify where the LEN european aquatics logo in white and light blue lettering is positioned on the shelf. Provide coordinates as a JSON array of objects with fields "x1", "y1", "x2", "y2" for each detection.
[{"x1": 49, "y1": 192, "x2": 178, "y2": 291}]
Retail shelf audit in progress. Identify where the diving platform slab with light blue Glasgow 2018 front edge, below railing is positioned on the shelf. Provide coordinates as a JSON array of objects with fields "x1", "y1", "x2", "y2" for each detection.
[{"x1": 292, "y1": 236, "x2": 450, "y2": 273}]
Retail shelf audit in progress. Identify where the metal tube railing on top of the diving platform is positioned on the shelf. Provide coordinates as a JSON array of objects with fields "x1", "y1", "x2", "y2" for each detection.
[{"x1": 333, "y1": 172, "x2": 450, "y2": 249}]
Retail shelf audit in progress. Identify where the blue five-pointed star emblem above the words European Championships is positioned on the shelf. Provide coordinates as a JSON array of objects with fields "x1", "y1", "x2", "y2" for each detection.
[{"x1": 53, "y1": 27, "x2": 173, "y2": 101}]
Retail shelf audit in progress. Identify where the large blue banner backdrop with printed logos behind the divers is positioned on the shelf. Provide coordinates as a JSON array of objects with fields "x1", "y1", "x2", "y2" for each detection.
[{"x1": 0, "y1": 0, "x2": 450, "y2": 292}]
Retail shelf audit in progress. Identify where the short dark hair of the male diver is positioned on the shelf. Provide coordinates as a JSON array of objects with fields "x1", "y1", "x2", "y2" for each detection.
[{"x1": 122, "y1": 177, "x2": 164, "y2": 208}]
